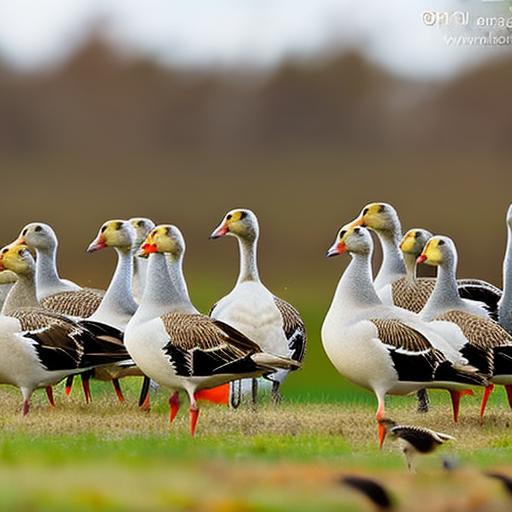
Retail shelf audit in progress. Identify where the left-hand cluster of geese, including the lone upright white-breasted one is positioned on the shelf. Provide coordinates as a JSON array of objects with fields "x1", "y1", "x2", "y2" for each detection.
[{"x1": 0, "y1": 209, "x2": 306, "y2": 435}]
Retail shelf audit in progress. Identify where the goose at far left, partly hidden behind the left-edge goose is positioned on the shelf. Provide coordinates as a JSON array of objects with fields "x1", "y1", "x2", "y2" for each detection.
[{"x1": 17, "y1": 222, "x2": 104, "y2": 318}]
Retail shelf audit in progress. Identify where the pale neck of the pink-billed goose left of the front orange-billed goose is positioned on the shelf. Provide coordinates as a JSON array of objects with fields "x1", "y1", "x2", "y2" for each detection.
[{"x1": 91, "y1": 247, "x2": 137, "y2": 323}]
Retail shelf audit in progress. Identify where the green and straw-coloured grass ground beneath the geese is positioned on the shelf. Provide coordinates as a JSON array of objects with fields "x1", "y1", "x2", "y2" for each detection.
[{"x1": 0, "y1": 382, "x2": 512, "y2": 512}]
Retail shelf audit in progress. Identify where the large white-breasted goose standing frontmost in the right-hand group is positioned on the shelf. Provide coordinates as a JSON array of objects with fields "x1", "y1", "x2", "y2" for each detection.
[{"x1": 321, "y1": 226, "x2": 486, "y2": 446}]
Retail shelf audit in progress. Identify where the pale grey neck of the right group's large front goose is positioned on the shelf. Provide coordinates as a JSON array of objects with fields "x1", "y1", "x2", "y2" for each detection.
[{"x1": 331, "y1": 254, "x2": 382, "y2": 315}]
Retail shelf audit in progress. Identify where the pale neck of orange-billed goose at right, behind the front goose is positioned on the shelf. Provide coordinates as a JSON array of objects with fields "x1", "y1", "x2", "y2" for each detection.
[{"x1": 421, "y1": 257, "x2": 466, "y2": 321}]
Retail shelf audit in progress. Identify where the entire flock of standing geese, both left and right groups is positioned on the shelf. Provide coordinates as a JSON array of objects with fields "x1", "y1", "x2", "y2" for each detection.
[{"x1": 0, "y1": 203, "x2": 512, "y2": 445}]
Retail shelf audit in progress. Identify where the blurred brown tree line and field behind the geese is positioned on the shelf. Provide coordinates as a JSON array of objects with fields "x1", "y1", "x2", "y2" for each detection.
[{"x1": 0, "y1": 32, "x2": 512, "y2": 396}]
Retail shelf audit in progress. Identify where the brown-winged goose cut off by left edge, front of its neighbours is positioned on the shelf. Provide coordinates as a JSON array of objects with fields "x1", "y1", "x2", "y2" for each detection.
[{"x1": 0, "y1": 244, "x2": 129, "y2": 415}]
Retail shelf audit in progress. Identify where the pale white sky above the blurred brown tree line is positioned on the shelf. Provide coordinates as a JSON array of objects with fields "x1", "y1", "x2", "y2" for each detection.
[{"x1": 0, "y1": 0, "x2": 512, "y2": 78}]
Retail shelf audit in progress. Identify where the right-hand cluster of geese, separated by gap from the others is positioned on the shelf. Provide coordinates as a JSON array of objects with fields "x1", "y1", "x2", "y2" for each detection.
[{"x1": 322, "y1": 203, "x2": 512, "y2": 445}]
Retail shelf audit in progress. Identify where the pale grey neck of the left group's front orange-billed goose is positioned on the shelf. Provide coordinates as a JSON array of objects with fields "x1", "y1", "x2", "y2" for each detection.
[{"x1": 136, "y1": 253, "x2": 197, "y2": 318}]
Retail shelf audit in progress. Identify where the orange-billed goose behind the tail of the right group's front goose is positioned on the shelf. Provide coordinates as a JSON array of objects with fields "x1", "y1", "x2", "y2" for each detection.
[{"x1": 418, "y1": 236, "x2": 512, "y2": 417}]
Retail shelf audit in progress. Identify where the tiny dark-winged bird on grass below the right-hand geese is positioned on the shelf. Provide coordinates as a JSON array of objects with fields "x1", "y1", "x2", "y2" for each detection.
[{"x1": 379, "y1": 418, "x2": 455, "y2": 472}]
